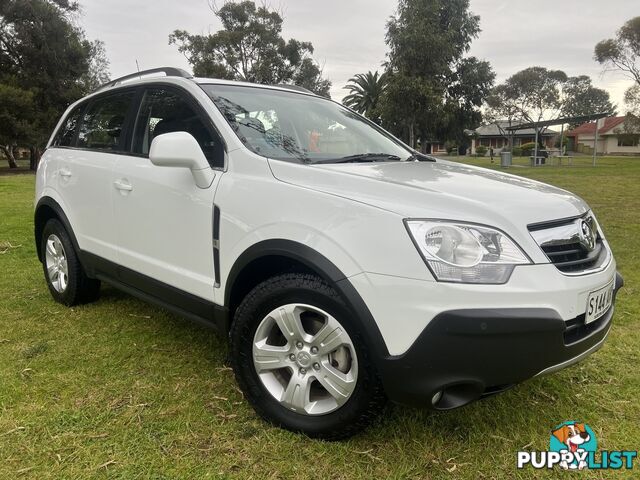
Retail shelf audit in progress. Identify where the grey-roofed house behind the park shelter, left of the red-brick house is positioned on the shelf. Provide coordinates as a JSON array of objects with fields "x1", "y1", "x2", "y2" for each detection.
[{"x1": 467, "y1": 120, "x2": 558, "y2": 155}]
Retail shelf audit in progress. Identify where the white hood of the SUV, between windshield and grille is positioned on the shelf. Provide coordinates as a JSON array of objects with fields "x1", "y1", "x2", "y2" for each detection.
[{"x1": 270, "y1": 160, "x2": 588, "y2": 229}]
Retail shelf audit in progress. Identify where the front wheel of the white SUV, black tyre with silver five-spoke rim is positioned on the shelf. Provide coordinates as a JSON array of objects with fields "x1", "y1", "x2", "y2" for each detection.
[{"x1": 230, "y1": 273, "x2": 386, "y2": 440}]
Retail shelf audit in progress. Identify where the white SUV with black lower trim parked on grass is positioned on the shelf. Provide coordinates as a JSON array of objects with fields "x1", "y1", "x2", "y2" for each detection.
[{"x1": 35, "y1": 68, "x2": 622, "y2": 439}]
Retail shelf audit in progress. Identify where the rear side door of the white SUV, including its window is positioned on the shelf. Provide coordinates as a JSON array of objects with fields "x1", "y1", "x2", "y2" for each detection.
[{"x1": 54, "y1": 90, "x2": 135, "y2": 262}]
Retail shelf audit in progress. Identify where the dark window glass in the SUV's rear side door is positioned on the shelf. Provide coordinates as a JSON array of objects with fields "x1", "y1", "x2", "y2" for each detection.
[{"x1": 77, "y1": 91, "x2": 135, "y2": 151}]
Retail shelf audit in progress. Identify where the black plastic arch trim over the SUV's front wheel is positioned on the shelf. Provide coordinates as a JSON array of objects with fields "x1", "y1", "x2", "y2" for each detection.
[{"x1": 224, "y1": 239, "x2": 396, "y2": 363}]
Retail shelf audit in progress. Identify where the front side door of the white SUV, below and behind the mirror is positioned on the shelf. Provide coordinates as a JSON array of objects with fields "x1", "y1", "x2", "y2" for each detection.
[{"x1": 113, "y1": 86, "x2": 224, "y2": 301}]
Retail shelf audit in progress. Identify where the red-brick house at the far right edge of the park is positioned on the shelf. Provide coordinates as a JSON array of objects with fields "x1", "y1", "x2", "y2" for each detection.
[{"x1": 567, "y1": 117, "x2": 640, "y2": 155}]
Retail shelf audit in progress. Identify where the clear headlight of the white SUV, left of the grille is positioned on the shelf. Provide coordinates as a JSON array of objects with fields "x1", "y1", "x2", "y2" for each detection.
[{"x1": 405, "y1": 220, "x2": 531, "y2": 284}]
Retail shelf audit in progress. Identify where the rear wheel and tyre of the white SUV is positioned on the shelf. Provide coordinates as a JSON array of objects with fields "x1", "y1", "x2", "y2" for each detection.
[{"x1": 40, "y1": 218, "x2": 100, "y2": 307}]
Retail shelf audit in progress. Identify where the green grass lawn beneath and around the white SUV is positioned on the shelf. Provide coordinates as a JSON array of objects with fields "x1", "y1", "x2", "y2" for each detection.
[{"x1": 0, "y1": 158, "x2": 640, "y2": 479}]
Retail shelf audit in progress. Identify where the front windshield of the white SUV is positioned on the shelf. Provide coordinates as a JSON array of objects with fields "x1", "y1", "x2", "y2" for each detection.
[{"x1": 202, "y1": 85, "x2": 412, "y2": 163}]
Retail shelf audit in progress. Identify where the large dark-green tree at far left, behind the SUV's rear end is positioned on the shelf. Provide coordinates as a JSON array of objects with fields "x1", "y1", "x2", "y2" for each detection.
[{"x1": 0, "y1": 0, "x2": 108, "y2": 168}]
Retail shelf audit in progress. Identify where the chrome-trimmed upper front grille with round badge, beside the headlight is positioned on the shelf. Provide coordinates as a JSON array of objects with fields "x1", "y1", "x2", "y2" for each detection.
[{"x1": 529, "y1": 214, "x2": 608, "y2": 275}]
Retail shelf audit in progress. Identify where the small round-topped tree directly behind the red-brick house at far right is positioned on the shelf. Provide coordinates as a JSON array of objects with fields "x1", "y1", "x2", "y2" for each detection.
[{"x1": 562, "y1": 75, "x2": 616, "y2": 127}]
